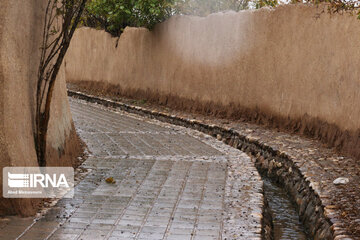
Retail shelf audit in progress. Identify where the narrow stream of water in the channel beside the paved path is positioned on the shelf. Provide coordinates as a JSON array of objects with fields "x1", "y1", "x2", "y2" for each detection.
[{"x1": 263, "y1": 177, "x2": 312, "y2": 240}]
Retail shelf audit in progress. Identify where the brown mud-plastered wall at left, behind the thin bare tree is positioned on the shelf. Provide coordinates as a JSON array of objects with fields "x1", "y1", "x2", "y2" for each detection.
[{"x1": 0, "y1": 0, "x2": 80, "y2": 215}]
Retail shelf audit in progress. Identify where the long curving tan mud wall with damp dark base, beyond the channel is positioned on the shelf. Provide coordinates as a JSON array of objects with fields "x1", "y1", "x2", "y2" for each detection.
[{"x1": 65, "y1": 5, "x2": 360, "y2": 157}]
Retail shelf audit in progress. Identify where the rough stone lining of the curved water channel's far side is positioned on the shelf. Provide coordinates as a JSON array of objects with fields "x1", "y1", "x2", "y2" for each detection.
[{"x1": 68, "y1": 90, "x2": 338, "y2": 239}]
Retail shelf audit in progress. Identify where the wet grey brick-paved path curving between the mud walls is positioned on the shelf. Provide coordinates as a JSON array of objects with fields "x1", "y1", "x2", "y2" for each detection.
[{"x1": 0, "y1": 99, "x2": 263, "y2": 240}]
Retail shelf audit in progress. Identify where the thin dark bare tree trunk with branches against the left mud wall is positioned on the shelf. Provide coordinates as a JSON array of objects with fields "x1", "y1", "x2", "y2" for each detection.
[{"x1": 34, "y1": 0, "x2": 87, "y2": 166}]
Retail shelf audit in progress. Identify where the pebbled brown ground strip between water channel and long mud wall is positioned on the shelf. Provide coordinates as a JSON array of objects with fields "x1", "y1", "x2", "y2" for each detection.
[{"x1": 79, "y1": 91, "x2": 360, "y2": 240}]
